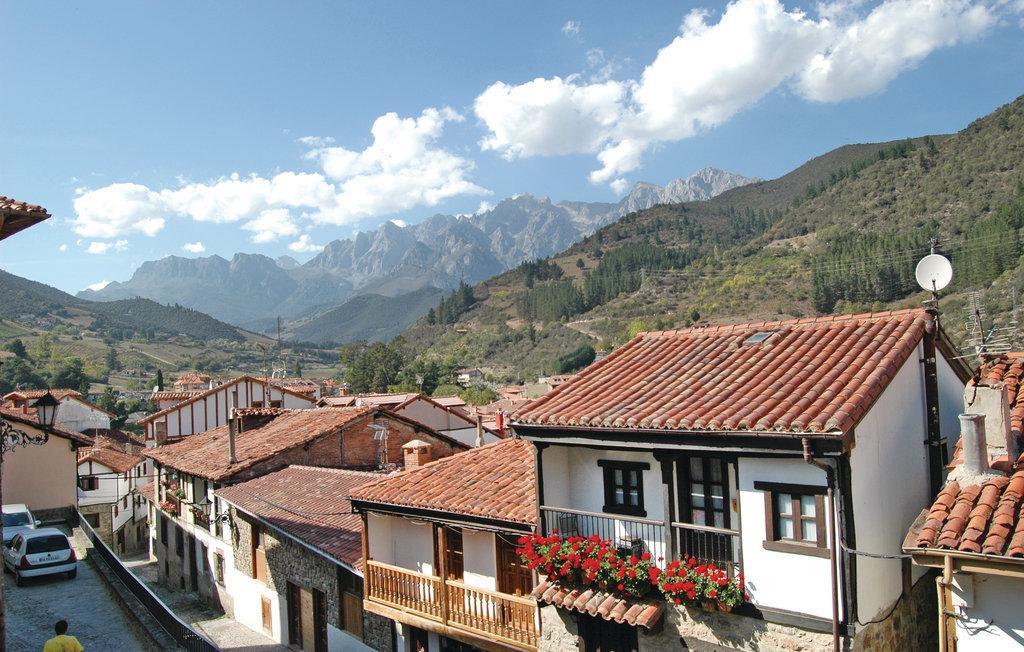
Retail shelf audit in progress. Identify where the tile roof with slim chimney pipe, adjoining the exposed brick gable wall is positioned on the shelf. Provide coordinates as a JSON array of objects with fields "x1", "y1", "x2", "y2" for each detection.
[{"x1": 142, "y1": 407, "x2": 374, "y2": 481}]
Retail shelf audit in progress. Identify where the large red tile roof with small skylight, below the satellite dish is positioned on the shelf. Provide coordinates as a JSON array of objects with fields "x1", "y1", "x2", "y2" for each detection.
[{"x1": 513, "y1": 309, "x2": 932, "y2": 434}]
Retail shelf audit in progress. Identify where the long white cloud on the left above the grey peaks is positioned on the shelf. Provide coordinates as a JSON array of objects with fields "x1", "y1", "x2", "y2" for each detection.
[{"x1": 74, "y1": 107, "x2": 489, "y2": 243}]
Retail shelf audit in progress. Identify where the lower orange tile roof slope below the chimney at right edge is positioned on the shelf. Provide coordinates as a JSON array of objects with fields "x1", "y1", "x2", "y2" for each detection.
[{"x1": 904, "y1": 471, "x2": 1024, "y2": 558}]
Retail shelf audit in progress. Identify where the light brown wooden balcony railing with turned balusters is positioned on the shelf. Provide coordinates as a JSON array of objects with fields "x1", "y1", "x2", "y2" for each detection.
[{"x1": 365, "y1": 561, "x2": 538, "y2": 650}]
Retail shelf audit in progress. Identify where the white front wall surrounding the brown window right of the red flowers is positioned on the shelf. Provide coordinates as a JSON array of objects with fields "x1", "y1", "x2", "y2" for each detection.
[{"x1": 738, "y1": 458, "x2": 842, "y2": 619}]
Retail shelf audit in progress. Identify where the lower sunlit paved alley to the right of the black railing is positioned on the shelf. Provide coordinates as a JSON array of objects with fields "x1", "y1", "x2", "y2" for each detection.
[{"x1": 125, "y1": 555, "x2": 290, "y2": 652}]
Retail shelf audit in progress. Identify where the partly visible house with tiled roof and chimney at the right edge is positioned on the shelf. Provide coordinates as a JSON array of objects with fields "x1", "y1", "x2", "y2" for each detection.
[{"x1": 903, "y1": 352, "x2": 1024, "y2": 652}]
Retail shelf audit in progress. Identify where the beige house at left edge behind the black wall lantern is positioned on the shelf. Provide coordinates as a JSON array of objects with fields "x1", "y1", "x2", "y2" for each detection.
[{"x1": 0, "y1": 400, "x2": 91, "y2": 522}]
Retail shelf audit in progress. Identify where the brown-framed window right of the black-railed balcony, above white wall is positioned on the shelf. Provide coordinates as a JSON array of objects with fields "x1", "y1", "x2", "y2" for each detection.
[{"x1": 754, "y1": 482, "x2": 828, "y2": 557}]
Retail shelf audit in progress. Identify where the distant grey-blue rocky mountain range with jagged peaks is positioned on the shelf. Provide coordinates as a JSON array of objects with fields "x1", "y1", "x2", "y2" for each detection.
[{"x1": 78, "y1": 168, "x2": 759, "y2": 341}]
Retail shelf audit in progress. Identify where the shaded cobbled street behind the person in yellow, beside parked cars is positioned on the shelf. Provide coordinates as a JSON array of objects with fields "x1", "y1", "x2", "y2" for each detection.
[{"x1": 3, "y1": 528, "x2": 159, "y2": 652}]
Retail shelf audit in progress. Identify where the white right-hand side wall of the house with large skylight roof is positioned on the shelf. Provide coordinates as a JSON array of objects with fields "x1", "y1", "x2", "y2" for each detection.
[{"x1": 850, "y1": 339, "x2": 932, "y2": 622}]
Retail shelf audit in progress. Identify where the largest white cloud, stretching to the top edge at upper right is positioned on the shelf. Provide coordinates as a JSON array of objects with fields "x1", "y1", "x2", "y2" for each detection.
[{"x1": 474, "y1": 0, "x2": 995, "y2": 187}]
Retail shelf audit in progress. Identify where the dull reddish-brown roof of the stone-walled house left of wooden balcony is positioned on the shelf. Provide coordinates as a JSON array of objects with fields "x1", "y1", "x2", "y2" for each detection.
[{"x1": 217, "y1": 466, "x2": 380, "y2": 568}]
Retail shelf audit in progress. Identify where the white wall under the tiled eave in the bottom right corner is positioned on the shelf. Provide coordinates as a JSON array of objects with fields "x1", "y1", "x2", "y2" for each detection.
[{"x1": 951, "y1": 573, "x2": 1024, "y2": 652}]
